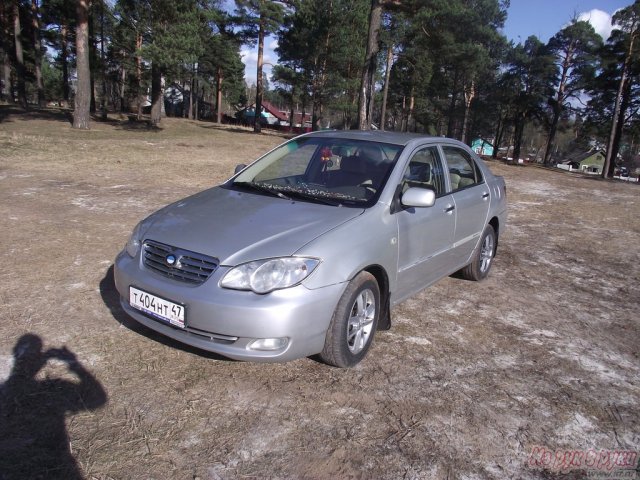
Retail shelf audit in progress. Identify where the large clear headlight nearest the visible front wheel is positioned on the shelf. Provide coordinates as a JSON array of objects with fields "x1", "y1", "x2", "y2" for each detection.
[{"x1": 220, "y1": 257, "x2": 320, "y2": 293}]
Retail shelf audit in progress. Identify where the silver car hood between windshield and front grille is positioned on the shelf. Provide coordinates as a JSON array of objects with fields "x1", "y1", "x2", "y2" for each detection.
[{"x1": 143, "y1": 187, "x2": 364, "y2": 266}]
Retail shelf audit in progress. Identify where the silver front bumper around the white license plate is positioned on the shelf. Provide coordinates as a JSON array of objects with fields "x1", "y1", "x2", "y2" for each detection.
[{"x1": 114, "y1": 251, "x2": 346, "y2": 362}]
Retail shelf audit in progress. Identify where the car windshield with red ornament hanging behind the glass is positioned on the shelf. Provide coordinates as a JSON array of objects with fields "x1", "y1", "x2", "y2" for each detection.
[{"x1": 231, "y1": 136, "x2": 403, "y2": 206}]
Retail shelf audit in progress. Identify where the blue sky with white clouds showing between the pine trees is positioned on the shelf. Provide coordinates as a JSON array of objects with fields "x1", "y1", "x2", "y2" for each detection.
[{"x1": 240, "y1": 0, "x2": 633, "y2": 84}]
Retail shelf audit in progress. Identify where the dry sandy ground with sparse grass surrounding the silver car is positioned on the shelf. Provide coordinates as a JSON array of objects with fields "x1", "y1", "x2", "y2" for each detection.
[{"x1": 0, "y1": 109, "x2": 640, "y2": 479}]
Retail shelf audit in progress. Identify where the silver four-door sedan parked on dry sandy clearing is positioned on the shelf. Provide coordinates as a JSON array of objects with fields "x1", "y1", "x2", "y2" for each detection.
[{"x1": 115, "y1": 131, "x2": 507, "y2": 367}]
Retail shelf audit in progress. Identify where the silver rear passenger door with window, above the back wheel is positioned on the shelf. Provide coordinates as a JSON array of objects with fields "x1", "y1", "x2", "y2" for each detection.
[{"x1": 442, "y1": 145, "x2": 491, "y2": 266}]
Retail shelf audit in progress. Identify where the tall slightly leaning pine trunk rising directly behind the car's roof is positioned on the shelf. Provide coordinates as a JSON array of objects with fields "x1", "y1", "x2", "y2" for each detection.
[{"x1": 358, "y1": 0, "x2": 382, "y2": 130}]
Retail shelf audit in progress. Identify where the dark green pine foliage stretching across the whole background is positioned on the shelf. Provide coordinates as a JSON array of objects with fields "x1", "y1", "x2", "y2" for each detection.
[{"x1": 0, "y1": 0, "x2": 640, "y2": 153}]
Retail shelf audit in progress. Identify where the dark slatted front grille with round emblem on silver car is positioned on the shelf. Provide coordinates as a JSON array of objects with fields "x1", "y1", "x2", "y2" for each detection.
[{"x1": 143, "y1": 240, "x2": 219, "y2": 285}]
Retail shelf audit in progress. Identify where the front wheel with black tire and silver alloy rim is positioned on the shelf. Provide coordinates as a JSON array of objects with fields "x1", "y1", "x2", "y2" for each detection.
[{"x1": 320, "y1": 272, "x2": 380, "y2": 368}]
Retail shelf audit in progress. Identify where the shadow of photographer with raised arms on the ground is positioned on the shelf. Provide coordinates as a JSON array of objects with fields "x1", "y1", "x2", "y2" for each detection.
[{"x1": 0, "y1": 334, "x2": 107, "y2": 480}]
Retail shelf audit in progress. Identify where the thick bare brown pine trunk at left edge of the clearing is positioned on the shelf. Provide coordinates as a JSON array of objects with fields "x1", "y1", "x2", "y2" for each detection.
[{"x1": 73, "y1": 0, "x2": 91, "y2": 129}]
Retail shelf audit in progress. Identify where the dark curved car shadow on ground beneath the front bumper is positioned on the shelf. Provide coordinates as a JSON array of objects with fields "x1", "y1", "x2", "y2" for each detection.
[{"x1": 99, "y1": 265, "x2": 235, "y2": 360}]
